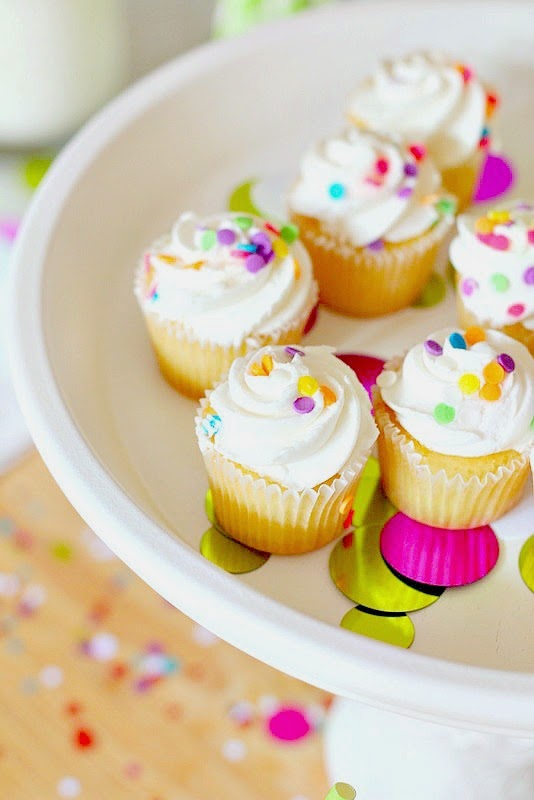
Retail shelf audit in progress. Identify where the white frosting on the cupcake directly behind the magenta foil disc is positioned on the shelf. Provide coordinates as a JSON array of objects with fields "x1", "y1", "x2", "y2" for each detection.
[{"x1": 377, "y1": 327, "x2": 534, "y2": 456}]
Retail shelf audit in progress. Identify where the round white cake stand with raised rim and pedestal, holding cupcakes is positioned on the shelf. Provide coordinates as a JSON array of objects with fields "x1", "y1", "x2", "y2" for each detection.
[{"x1": 7, "y1": 2, "x2": 534, "y2": 800}]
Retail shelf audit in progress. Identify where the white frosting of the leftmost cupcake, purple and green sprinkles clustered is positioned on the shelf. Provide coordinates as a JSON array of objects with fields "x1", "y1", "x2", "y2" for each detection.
[{"x1": 135, "y1": 213, "x2": 317, "y2": 346}]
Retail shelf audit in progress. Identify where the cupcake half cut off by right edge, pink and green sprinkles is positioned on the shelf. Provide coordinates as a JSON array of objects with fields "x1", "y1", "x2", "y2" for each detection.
[{"x1": 450, "y1": 200, "x2": 534, "y2": 355}]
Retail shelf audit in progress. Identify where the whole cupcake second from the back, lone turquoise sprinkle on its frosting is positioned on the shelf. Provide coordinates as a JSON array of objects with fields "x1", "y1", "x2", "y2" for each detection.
[{"x1": 288, "y1": 128, "x2": 456, "y2": 317}]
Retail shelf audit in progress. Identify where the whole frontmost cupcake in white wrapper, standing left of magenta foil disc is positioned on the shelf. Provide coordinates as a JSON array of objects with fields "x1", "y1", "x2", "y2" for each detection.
[{"x1": 196, "y1": 345, "x2": 377, "y2": 554}]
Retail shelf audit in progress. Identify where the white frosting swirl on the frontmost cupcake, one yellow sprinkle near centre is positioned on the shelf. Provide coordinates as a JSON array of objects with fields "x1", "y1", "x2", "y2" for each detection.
[{"x1": 197, "y1": 346, "x2": 377, "y2": 490}]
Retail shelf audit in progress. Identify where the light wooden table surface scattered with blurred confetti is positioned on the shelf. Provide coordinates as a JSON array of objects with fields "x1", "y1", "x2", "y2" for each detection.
[{"x1": 0, "y1": 454, "x2": 332, "y2": 800}]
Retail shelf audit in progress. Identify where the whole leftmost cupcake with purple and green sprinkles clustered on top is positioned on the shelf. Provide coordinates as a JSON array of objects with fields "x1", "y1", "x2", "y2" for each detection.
[{"x1": 135, "y1": 213, "x2": 317, "y2": 398}]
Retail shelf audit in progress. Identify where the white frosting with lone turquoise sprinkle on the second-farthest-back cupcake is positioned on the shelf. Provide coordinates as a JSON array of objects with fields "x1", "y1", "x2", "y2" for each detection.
[{"x1": 288, "y1": 128, "x2": 456, "y2": 250}]
